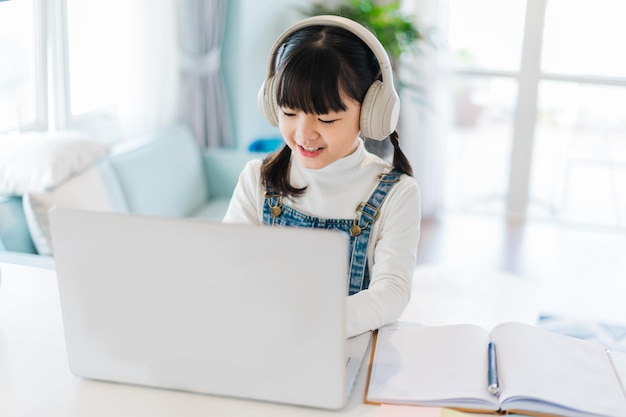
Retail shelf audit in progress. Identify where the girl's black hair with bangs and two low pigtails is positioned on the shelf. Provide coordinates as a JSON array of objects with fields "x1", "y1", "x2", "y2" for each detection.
[{"x1": 261, "y1": 25, "x2": 413, "y2": 196}]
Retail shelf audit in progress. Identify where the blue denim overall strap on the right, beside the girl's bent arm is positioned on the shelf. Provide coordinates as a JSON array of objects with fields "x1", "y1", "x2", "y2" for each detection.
[{"x1": 348, "y1": 170, "x2": 402, "y2": 295}]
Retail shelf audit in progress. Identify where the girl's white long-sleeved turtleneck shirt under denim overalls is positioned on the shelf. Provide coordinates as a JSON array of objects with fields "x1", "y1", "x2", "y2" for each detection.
[{"x1": 224, "y1": 142, "x2": 421, "y2": 337}]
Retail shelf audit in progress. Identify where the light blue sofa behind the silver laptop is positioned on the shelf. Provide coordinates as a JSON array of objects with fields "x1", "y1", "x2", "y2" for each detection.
[{"x1": 0, "y1": 124, "x2": 264, "y2": 267}]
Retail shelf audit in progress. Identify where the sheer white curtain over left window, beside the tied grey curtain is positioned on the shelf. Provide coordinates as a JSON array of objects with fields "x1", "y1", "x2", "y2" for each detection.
[{"x1": 66, "y1": 0, "x2": 179, "y2": 141}]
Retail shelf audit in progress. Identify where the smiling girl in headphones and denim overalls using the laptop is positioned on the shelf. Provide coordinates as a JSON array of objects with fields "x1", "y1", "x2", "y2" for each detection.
[{"x1": 224, "y1": 16, "x2": 421, "y2": 337}]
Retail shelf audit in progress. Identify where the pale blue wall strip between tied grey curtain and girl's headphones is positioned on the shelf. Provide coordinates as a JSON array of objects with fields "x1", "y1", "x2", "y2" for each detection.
[{"x1": 222, "y1": 0, "x2": 309, "y2": 149}]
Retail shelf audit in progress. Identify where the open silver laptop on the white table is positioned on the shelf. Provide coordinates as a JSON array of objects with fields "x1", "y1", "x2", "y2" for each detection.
[{"x1": 50, "y1": 208, "x2": 369, "y2": 409}]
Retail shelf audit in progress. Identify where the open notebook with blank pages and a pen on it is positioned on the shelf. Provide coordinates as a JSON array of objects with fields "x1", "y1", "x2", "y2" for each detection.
[{"x1": 366, "y1": 322, "x2": 626, "y2": 417}]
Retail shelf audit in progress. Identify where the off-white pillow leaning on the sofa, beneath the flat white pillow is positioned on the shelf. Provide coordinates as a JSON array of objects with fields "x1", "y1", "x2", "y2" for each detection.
[{"x1": 22, "y1": 167, "x2": 113, "y2": 255}]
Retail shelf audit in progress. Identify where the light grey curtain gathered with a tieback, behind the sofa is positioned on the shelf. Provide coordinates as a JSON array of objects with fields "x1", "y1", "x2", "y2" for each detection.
[{"x1": 177, "y1": 0, "x2": 233, "y2": 148}]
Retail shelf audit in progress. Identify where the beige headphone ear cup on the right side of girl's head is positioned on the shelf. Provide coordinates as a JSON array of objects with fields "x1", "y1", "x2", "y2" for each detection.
[{"x1": 359, "y1": 80, "x2": 400, "y2": 140}]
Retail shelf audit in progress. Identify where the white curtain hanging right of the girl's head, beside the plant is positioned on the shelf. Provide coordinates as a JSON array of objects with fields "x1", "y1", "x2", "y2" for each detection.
[{"x1": 399, "y1": 0, "x2": 450, "y2": 218}]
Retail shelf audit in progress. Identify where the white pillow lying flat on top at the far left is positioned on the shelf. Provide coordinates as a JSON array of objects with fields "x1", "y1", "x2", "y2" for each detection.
[{"x1": 0, "y1": 132, "x2": 109, "y2": 194}]
